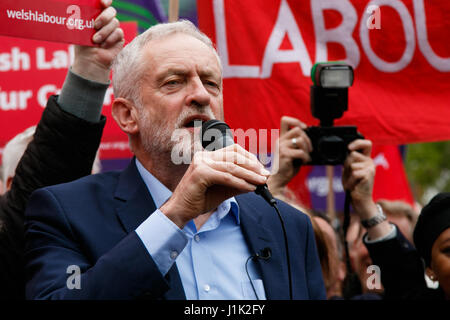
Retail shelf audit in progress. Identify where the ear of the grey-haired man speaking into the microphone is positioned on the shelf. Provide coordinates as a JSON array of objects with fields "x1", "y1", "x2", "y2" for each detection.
[{"x1": 111, "y1": 98, "x2": 139, "y2": 135}]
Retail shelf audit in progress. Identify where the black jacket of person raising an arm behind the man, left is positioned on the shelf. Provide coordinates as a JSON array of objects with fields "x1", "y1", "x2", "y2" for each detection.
[{"x1": 0, "y1": 96, "x2": 106, "y2": 299}]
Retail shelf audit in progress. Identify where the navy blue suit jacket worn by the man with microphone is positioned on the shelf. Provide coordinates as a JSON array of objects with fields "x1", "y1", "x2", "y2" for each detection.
[{"x1": 25, "y1": 161, "x2": 326, "y2": 299}]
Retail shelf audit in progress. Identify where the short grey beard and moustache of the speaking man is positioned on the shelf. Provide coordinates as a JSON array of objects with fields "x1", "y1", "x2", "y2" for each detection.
[{"x1": 139, "y1": 106, "x2": 215, "y2": 165}]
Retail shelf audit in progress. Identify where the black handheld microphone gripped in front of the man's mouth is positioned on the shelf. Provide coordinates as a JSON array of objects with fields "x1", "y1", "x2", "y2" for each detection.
[{"x1": 200, "y1": 119, "x2": 276, "y2": 207}]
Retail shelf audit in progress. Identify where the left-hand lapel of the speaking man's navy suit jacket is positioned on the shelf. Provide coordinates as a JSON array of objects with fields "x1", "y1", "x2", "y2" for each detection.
[{"x1": 114, "y1": 158, "x2": 186, "y2": 300}]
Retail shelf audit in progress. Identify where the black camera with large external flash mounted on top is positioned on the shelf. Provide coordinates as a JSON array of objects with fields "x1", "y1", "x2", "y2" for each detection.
[{"x1": 305, "y1": 62, "x2": 364, "y2": 165}]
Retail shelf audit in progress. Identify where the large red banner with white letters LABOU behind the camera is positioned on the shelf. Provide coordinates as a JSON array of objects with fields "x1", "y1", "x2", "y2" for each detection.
[{"x1": 197, "y1": 0, "x2": 450, "y2": 145}]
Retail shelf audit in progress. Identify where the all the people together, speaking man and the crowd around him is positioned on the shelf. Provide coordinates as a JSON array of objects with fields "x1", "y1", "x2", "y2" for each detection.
[{"x1": 0, "y1": 0, "x2": 450, "y2": 300}]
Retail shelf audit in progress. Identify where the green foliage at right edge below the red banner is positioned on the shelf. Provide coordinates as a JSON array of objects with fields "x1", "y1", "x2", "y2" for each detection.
[{"x1": 405, "y1": 141, "x2": 450, "y2": 205}]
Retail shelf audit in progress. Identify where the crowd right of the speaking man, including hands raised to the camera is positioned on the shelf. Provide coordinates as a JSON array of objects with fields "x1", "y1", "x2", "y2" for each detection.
[{"x1": 267, "y1": 117, "x2": 450, "y2": 300}]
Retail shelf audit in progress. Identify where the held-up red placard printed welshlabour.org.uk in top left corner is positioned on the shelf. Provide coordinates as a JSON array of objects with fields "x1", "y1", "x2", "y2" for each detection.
[{"x1": 0, "y1": 0, "x2": 101, "y2": 45}]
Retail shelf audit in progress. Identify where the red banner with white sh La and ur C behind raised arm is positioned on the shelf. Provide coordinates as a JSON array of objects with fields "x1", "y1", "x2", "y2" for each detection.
[{"x1": 0, "y1": 22, "x2": 137, "y2": 159}]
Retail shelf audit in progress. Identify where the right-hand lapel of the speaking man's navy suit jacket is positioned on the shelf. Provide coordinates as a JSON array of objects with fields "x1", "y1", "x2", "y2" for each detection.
[{"x1": 235, "y1": 195, "x2": 289, "y2": 300}]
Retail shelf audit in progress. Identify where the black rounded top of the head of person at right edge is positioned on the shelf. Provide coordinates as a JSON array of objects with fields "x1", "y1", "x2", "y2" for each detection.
[{"x1": 413, "y1": 192, "x2": 450, "y2": 267}]
